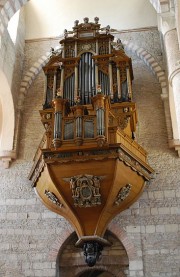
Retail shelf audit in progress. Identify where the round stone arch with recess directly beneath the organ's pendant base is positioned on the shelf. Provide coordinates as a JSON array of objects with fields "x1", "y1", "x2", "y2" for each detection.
[{"x1": 49, "y1": 225, "x2": 131, "y2": 277}]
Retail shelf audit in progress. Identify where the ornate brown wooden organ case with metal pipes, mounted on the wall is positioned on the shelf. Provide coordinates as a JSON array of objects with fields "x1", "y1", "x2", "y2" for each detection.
[{"x1": 30, "y1": 17, "x2": 153, "y2": 266}]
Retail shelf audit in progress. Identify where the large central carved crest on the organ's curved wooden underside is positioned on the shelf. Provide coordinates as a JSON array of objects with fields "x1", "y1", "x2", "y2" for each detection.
[{"x1": 64, "y1": 174, "x2": 103, "y2": 207}]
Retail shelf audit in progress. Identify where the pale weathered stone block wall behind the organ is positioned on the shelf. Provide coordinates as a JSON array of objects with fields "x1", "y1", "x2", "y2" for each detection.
[{"x1": 0, "y1": 30, "x2": 180, "y2": 277}]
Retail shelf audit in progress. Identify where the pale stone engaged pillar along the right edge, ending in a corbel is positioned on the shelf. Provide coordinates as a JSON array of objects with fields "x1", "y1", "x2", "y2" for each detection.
[{"x1": 158, "y1": 10, "x2": 180, "y2": 155}]
